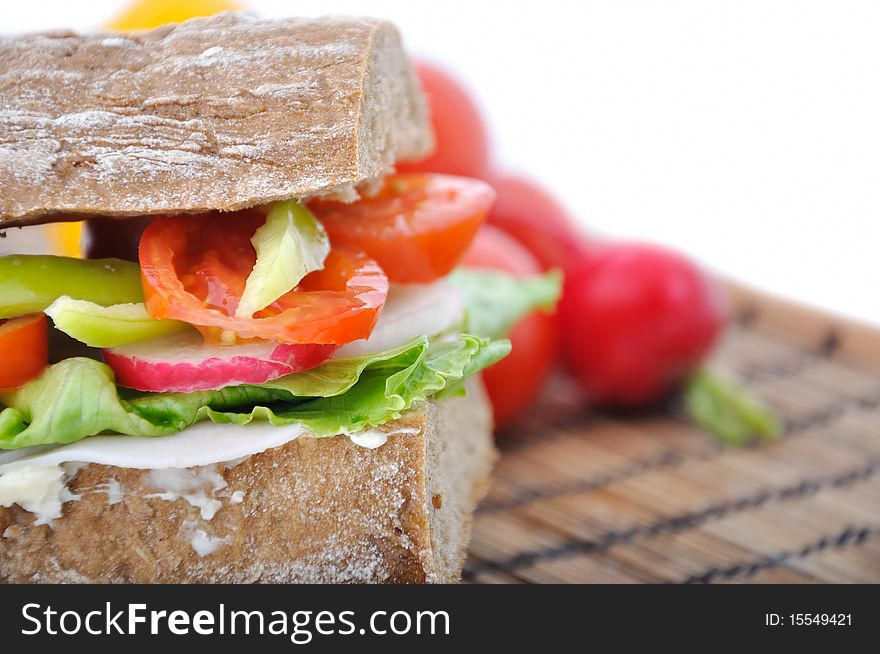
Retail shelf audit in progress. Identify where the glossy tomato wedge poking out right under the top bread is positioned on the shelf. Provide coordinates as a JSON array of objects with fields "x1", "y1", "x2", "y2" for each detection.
[{"x1": 309, "y1": 174, "x2": 495, "y2": 284}]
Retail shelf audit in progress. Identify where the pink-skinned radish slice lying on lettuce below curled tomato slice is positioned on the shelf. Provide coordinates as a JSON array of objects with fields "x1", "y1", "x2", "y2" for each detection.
[{"x1": 104, "y1": 332, "x2": 336, "y2": 393}]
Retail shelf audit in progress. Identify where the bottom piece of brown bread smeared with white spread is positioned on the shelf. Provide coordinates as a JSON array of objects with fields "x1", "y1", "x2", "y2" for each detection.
[{"x1": 0, "y1": 380, "x2": 495, "y2": 583}]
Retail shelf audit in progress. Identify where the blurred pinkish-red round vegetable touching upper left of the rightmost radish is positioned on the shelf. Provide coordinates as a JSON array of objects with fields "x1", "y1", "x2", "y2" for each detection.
[{"x1": 488, "y1": 174, "x2": 587, "y2": 270}]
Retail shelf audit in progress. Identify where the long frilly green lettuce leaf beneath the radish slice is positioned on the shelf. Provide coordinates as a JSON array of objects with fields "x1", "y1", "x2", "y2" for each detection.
[{"x1": 0, "y1": 334, "x2": 510, "y2": 449}]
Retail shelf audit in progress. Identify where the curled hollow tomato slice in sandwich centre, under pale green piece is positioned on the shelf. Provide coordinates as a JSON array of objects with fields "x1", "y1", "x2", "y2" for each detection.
[{"x1": 139, "y1": 210, "x2": 388, "y2": 345}]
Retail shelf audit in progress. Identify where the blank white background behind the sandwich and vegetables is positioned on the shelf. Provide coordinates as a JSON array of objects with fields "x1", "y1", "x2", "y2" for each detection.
[{"x1": 6, "y1": 0, "x2": 880, "y2": 325}]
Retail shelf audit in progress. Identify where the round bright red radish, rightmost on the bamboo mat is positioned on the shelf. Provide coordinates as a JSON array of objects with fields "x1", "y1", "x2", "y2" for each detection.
[{"x1": 559, "y1": 244, "x2": 725, "y2": 407}]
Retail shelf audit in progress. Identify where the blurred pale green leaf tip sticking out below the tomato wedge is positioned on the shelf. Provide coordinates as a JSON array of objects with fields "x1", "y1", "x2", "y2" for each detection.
[{"x1": 449, "y1": 268, "x2": 562, "y2": 338}]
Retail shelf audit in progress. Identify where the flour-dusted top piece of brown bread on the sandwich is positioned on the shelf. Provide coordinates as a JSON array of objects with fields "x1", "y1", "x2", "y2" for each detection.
[{"x1": 0, "y1": 13, "x2": 432, "y2": 228}]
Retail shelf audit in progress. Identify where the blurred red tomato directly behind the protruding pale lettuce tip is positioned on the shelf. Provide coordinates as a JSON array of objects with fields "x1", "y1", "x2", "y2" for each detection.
[{"x1": 462, "y1": 225, "x2": 558, "y2": 427}]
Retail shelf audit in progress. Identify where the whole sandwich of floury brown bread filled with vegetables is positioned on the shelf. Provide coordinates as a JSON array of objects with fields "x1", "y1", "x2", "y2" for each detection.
[{"x1": 0, "y1": 13, "x2": 559, "y2": 583}]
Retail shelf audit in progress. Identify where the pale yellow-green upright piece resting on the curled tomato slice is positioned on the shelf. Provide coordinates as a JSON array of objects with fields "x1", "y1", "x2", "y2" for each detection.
[{"x1": 235, "y1": 200, "x2": 330, "y2": 318}]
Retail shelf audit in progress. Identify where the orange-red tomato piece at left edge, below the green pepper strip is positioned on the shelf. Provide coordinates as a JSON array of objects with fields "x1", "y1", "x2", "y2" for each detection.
[{"x1": 0, "y1": 313, "x2": 49, "y2": 389}]
